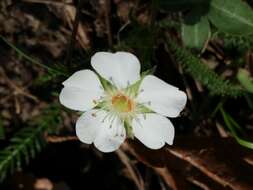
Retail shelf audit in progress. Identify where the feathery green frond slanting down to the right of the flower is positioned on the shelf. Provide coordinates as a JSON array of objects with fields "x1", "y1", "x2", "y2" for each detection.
[{"x1": 167, "y1": 40, "x2": 243, "y2": 98}]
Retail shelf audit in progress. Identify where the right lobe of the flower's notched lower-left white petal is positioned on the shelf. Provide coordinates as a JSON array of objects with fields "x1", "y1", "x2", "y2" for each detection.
[{"x1": 94, "y1": 114, "x2": 126, "y2": 152}]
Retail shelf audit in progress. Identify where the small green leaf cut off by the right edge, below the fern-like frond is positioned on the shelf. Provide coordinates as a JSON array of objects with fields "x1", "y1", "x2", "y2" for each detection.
[{"x1": 237, "y1": 69, "x2": 253, "y2": 93}]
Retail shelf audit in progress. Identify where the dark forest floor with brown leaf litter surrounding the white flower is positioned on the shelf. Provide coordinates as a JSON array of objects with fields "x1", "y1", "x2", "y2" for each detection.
[{"x1": 0, "y1": 0, "x2": 253, "y2": 190}]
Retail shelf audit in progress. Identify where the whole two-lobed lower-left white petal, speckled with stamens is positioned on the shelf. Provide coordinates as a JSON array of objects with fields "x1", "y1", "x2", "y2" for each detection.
[{"x1": 76, "y1": 109, "x2": 126, "y2": 152}]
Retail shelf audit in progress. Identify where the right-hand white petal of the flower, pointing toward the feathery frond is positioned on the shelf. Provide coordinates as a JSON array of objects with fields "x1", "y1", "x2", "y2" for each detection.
[{"x1": 137, "y1": 75, "x2": 187, "y2": 117}]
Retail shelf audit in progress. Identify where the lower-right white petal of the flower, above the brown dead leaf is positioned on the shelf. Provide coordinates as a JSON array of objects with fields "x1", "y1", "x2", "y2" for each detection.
[{"x1": 132, "y1": 113, "x2": 175, "y2": 149}]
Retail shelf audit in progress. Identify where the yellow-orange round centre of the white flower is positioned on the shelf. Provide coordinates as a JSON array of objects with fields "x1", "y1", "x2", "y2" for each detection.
[{"x1": 111, "y1": 94, "x2": 134, "y2": 112}]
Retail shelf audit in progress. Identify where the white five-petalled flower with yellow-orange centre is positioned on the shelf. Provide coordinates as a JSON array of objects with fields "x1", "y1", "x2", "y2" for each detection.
[{"x1": 60, "y1": 52, "x2": 187, "y2": 152}]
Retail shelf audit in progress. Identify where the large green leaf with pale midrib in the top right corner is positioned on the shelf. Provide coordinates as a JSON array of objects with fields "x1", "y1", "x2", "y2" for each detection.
[{"x1": 208, "y1": 0, "x2": 253, "y2": 35}]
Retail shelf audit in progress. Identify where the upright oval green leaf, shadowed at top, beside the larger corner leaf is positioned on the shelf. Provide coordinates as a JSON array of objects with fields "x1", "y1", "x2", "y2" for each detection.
[{"x1": 182, "y1": 13, "x2": 211, "y2": 50}]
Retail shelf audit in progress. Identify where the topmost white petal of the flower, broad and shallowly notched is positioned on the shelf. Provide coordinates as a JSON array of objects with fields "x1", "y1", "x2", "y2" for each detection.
[{"x1": 91, "y1": 52, "x2": 140, "y2": 88}]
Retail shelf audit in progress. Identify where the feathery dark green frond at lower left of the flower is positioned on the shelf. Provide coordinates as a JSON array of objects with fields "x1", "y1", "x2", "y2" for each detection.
[{"x1": 0, "y1": 107, "x2": 59, "y2": 181}]
